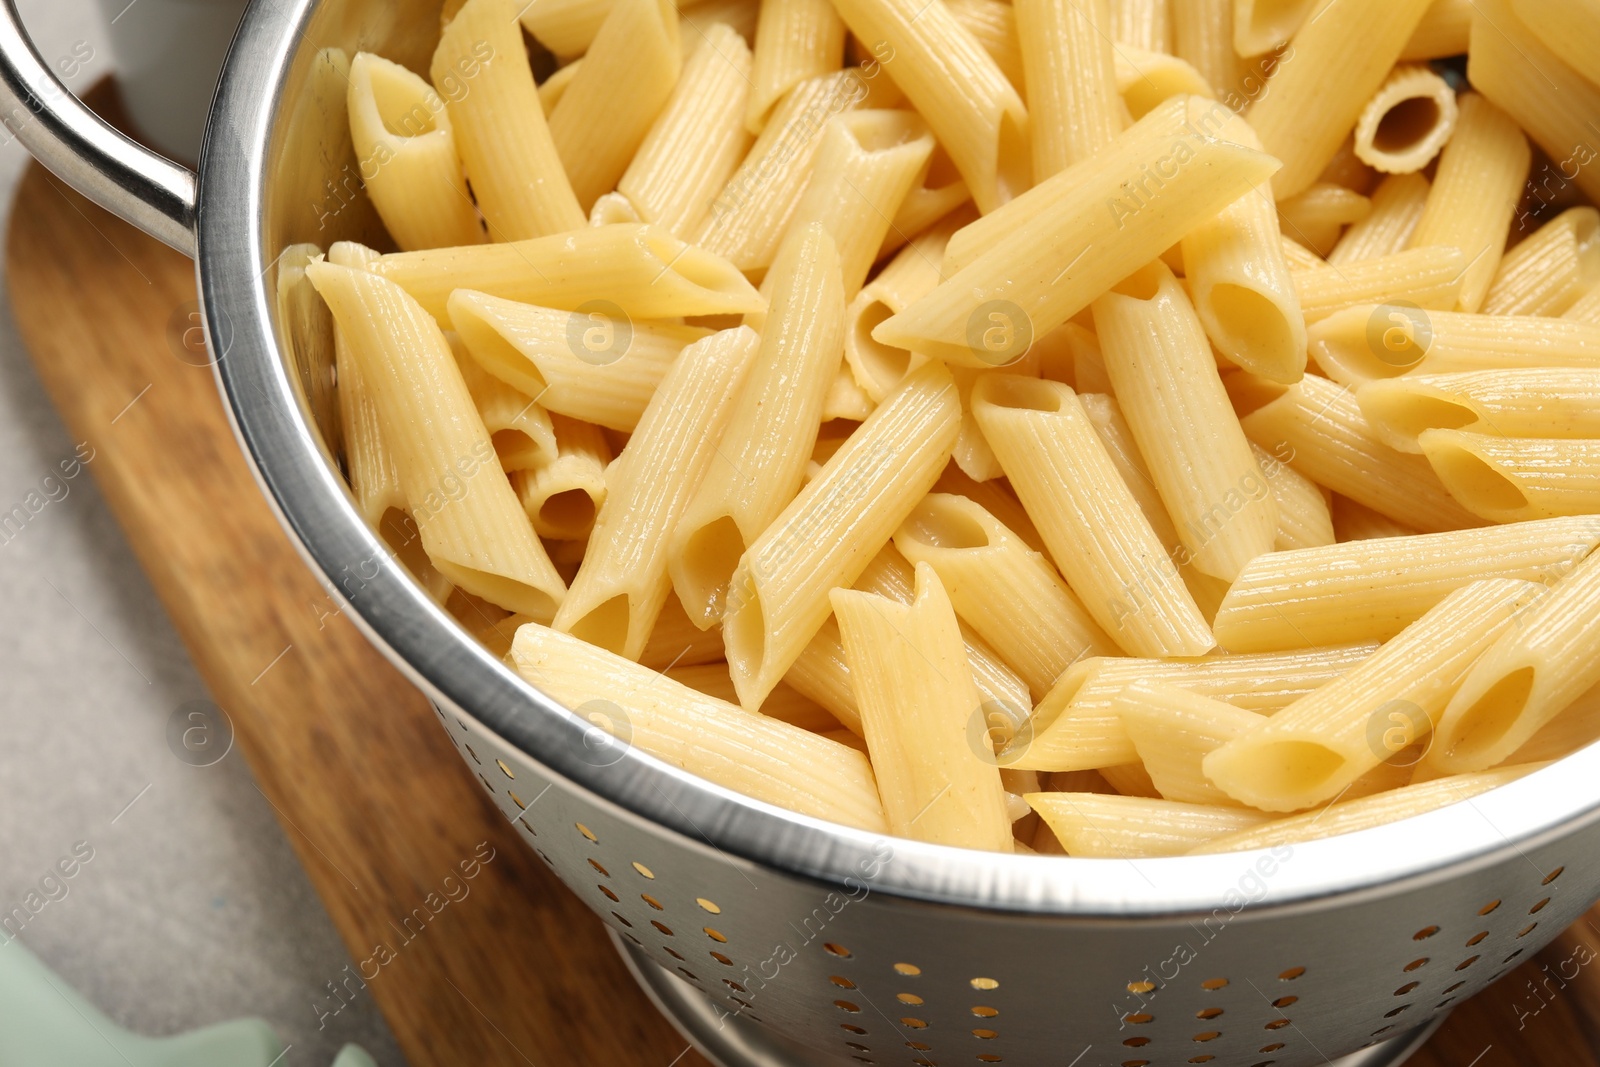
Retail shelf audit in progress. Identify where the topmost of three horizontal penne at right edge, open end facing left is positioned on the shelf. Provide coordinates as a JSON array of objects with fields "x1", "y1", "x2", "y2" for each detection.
[{"x1": 1307, "y1": 304, "x2": 1600, "y2": 386}]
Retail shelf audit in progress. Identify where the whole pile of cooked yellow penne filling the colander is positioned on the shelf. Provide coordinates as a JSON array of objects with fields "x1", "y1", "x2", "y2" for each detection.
[{"x1": 300, "y1": 0, "x2": 1600, "y2": 857}]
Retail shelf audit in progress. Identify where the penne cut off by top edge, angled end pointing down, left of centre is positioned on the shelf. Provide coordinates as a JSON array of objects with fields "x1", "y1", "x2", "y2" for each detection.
[{"x1": 550, "y1": 0, "x2": 683, "y2": 211}]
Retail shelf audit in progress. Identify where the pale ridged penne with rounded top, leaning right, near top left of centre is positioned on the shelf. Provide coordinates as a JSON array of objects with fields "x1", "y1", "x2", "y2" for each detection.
[{"x1": 617, "y1": 22, "x2": 750, "y2": 238}]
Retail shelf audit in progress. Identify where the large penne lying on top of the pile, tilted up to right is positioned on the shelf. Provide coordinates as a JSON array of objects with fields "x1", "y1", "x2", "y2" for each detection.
[{"x1": 872, "y1": 98, "x2": 1275, "y2": 368}]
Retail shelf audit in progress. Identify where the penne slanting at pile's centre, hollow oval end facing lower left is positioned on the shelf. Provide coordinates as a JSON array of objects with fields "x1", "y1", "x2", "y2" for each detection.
[{"x1": 723, "y1": 365, "x2": 962, "y2": 709}]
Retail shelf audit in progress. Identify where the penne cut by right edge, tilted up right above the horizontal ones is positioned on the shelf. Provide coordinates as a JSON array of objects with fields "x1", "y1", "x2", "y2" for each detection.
[{"x1": 1482, "y1": 208, "x2": 1600, "y2": 317}]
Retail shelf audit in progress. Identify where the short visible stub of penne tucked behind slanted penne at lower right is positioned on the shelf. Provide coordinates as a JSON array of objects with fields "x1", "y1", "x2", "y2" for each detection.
[{"x1": 1112, "y1": 681, "x2": 1261, "y2": 805}]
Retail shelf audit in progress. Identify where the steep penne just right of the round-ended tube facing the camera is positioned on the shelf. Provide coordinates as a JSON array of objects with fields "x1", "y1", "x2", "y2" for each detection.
[{"x1": 1411, "y1": 93, "x2": 1531, "y2": 312}]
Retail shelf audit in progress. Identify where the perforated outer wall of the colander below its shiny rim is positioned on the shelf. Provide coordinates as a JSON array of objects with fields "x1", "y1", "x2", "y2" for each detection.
[{"x1": 440, "y1": 700, "x2": 1600, "y2": 1067}]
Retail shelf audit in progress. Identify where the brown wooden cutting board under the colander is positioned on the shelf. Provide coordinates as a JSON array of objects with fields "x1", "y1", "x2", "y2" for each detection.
[{"x1": 6, "y1": 98, "x2": 1600, "y2": 1067}]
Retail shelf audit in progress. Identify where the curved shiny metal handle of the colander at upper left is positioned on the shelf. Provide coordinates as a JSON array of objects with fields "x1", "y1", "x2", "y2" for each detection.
[{"x1": 0, "y1": 0, "x2": 195, "y2": 259}]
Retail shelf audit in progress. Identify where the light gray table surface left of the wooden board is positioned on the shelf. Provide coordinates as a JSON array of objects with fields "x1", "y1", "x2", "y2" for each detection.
[{"x1": 0, "y1": 0, "x2": 403, "y2": 1067}]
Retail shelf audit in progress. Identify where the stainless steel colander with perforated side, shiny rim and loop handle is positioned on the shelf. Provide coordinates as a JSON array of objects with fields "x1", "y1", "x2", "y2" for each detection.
[{"x1": 0, "y1": 0, "x2": 1600, "y2": 1067}]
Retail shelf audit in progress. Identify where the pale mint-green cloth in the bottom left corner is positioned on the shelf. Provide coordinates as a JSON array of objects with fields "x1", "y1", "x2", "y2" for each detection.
[{"x1": 0, "y1": 937, "x2": 378, "y2": 1067}]
